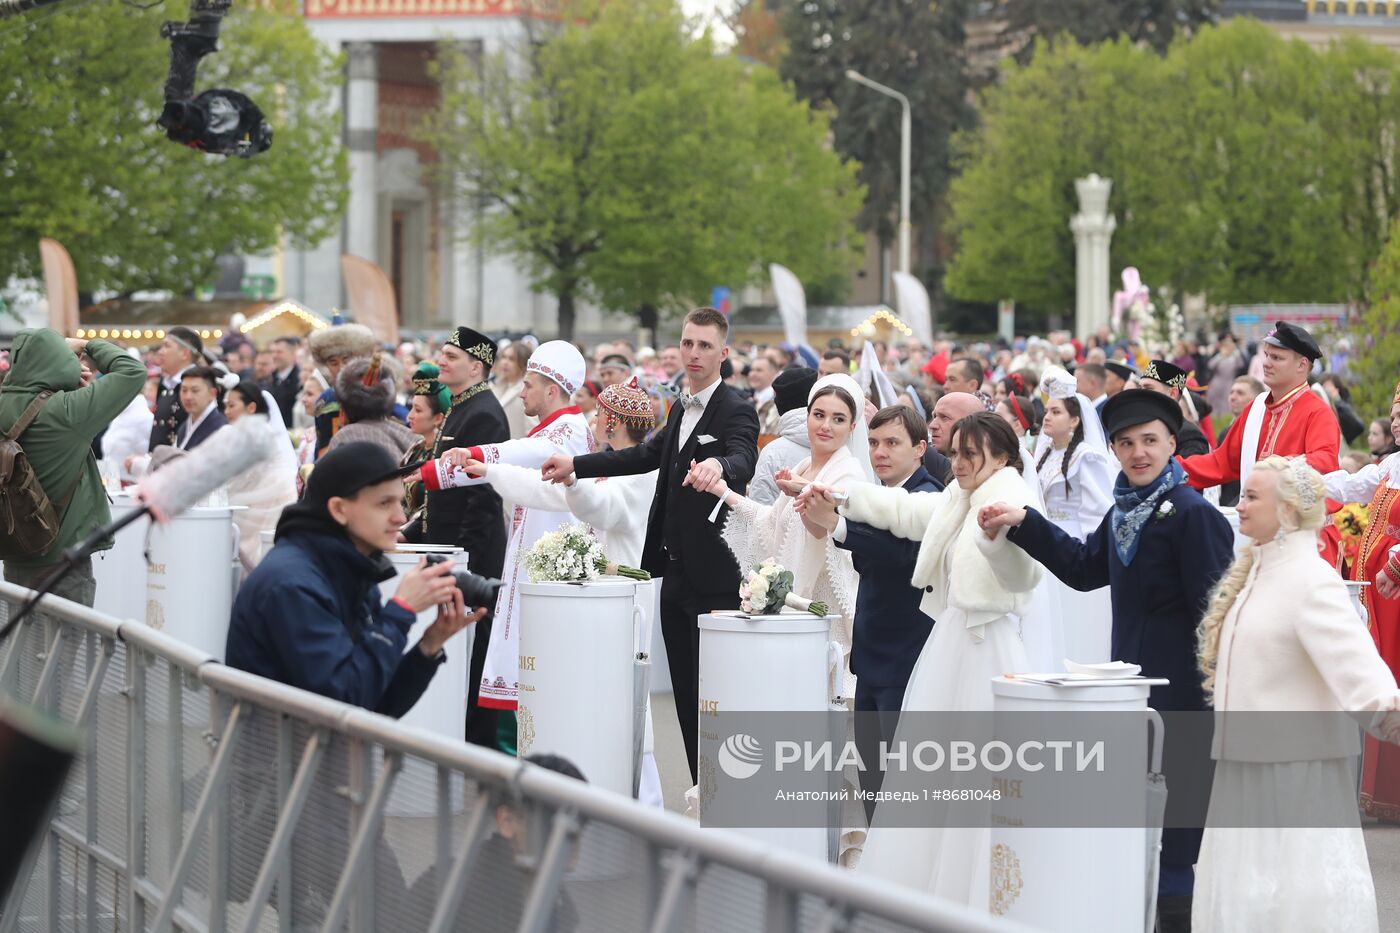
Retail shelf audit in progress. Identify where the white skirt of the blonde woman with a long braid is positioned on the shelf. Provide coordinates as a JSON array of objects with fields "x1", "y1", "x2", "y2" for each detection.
[{"x1": 1191, "y1": 758, "x2": 1379, "y2": 933}]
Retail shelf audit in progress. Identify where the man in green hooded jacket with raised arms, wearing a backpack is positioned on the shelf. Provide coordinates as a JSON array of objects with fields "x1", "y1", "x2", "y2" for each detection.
[{"x1": 0, "y1": 328, "x2": 146, "y2": 605}]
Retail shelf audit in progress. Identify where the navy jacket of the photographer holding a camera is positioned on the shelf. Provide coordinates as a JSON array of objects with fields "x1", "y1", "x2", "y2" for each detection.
[{"x1": 225, "y1": 520, "x2": 442, "y2": 716}]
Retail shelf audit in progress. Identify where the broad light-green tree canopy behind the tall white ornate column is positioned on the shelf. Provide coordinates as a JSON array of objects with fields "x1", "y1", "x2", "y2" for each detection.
[{"x1": 948, "y1": 20, "x2": 1366, "y2": 323}]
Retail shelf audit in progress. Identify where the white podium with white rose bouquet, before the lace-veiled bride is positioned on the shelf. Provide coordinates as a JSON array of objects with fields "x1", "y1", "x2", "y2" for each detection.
[{"x1": 697, "y1": 612, "x2": 839, "y2": 862}]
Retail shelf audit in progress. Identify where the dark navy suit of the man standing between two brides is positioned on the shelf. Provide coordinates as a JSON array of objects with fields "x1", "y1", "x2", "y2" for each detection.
[{"x1": 836, "y1": 467, "x2": 944, "y2": 686}]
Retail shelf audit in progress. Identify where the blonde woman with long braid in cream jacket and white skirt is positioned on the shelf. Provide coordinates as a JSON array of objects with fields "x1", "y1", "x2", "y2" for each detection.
[{"x1": 1191, "y1": 457, "x2": 1400, "y2": 933}]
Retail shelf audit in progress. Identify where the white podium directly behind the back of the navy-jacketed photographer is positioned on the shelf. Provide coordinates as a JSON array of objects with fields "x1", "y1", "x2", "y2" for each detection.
[{"x1": 137, "y1": 506, "x2": 238, "y2": 663}]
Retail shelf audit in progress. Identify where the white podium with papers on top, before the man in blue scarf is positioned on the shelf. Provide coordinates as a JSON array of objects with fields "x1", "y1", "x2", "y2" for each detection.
[{"x1": 991, "y1": 678, "x2": 1162, "y2": 933}]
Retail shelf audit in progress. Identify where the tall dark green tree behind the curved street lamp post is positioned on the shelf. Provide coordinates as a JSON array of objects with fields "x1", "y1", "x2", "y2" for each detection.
[{"x1": 781, "y1": 0, "x2": 973, "y2": 294}]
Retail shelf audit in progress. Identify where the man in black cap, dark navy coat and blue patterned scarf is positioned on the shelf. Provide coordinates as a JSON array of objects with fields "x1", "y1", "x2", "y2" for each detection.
[{"x1": 977, "y1": 389, "x2": 1235, "y2": 932}]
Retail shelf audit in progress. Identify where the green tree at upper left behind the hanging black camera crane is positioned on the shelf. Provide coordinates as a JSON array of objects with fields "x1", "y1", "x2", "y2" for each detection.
[{"x1": 0, "y1": 1, "x2": 349, "y2": 293}]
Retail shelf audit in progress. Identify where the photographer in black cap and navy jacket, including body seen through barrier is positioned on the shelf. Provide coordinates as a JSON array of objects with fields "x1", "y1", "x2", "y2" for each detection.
[{"x1": 225, "y1": 441, "x2": 486, "y2": 929}]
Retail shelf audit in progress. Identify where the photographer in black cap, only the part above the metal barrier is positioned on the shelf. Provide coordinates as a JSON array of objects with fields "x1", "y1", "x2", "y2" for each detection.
[{"x1": 225, "y1": 441, "x2": 486, "y2": 716}]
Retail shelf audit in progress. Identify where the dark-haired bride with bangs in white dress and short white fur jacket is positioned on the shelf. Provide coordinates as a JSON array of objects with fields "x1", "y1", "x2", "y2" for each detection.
[{"x1": 801, "y1": 412, "x2": 1042, "y2": 909}]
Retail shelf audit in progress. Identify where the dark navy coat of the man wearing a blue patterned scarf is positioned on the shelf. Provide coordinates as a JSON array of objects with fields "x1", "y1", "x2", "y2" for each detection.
[{"x1": 1008, "y1": 483, "x2": 1235, "y2": 710}]
